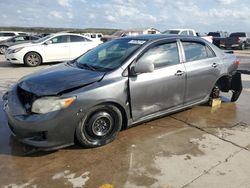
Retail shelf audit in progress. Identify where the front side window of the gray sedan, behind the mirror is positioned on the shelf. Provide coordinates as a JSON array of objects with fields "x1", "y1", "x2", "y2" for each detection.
[{"x1": 138, "y1": 42, "x2": 180, "y2": 68}]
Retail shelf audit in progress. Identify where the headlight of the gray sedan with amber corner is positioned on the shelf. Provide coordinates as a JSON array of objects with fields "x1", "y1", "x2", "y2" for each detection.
[{"x1": 31, "y1": 97, "x2": 76, "y2": 114}]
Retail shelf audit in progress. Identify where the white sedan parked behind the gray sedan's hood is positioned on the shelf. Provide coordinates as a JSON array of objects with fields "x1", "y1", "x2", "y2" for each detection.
[{"x1": 5, "y1": 33, "x2": 98, "y2": 67}]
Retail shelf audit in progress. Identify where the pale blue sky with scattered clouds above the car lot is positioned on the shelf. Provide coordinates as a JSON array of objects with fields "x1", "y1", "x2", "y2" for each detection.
[{"x1": 0, "y1": 0, "x2": 250, "y2": 32}]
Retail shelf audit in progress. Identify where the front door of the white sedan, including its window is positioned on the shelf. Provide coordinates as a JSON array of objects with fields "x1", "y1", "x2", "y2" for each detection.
[{"x1": 43, "y1": 35, "x2": 70, "y2": 62}]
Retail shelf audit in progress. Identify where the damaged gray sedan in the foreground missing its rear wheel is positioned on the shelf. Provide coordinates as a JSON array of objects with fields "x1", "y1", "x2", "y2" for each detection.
[{"x1": 3, "y1": 35, "x2": 242, "y2": 149}]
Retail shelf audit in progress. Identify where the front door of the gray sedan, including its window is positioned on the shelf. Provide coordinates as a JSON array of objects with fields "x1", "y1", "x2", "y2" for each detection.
[{"x1": 129, "y1": 40, "x2": 185, "y2": 121}]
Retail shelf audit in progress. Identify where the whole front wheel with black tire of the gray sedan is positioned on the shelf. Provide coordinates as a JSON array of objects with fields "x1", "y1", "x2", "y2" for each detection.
[{"x1": 76, "y1": 105, "x2": 122, "y2": 148}]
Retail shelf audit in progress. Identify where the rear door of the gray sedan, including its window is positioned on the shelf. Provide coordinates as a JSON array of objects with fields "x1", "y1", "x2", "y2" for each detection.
[{"x1": 182, "y1": 40, "x2": 220, "y2": 103}]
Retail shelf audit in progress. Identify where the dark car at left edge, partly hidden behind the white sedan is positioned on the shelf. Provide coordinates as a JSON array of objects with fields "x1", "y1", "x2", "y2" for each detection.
[{"x1": 0, "y1": 35, "x2": 40, "y2": 54}]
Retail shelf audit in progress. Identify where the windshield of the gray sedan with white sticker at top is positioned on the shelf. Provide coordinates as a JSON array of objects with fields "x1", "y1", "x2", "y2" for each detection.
[{"x1": 76, "y1": 39, "x2": 146, "y2": 71}]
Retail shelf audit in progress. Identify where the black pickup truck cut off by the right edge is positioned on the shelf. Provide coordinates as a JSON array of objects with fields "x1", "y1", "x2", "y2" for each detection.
[{"x1": 220, "y1": 32, "x2": 250, "y2": 50}]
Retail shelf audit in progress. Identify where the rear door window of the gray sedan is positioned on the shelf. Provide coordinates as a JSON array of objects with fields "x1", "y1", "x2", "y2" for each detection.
[{"x1": 182, "y1": 42, "x2": 215, "y2": 62}]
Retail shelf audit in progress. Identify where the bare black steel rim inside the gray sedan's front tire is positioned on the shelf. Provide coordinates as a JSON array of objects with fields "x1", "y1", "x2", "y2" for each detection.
[{"x1": 92, "y1": 112, "x2": 113, "y2": 136}]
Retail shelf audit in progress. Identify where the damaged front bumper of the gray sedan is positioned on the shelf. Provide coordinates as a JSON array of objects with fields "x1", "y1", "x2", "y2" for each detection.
[{"x1": 3, "y1": 88, "x2": 79, "y2": 150}]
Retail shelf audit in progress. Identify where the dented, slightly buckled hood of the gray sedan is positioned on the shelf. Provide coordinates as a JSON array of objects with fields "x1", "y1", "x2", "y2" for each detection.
[{"x1": 18, "y1": 63, "x2": 105, "y2": 96}]
